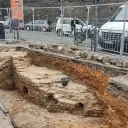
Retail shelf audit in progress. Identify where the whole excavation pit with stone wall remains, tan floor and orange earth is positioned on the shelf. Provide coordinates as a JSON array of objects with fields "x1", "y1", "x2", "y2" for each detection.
[{"x1": 0, "y1": 48, "x2": 128, "y2": 128}]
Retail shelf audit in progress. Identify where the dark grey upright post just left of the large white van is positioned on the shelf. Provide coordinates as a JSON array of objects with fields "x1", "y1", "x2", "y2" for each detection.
[{"x1": 94, "y1": 4, "x2": 98, "y2": 52}]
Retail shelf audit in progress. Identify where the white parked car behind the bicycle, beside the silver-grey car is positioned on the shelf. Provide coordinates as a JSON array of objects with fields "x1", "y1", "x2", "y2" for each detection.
[{"x1": 56, "y1": 17, "x2": 93, "y2": 36}]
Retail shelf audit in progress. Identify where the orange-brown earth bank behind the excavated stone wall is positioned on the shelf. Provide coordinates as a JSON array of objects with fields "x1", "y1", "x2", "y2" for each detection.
[{"x1": 29, "y1": 54, "x2": 128, "y2": 128}]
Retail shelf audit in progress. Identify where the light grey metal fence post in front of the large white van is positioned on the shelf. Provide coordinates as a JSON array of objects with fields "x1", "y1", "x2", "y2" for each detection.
[{"x1": 120, "y1": 2, "x2": 128, "y2": 59}]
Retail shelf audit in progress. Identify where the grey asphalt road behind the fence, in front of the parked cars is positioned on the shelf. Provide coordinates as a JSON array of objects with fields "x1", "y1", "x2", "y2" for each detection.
[{"x1": 0, "y1": 29, "x2": 128, "y2": 56}]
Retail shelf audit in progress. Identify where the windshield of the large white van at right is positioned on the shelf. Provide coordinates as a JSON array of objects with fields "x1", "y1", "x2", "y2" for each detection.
[{"x1": 110, "y1": 7, "x2": 128, "y2": 22}]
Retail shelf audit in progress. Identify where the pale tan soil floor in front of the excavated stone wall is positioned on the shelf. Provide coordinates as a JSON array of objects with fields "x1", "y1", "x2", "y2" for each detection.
[{"x1": 0, "y1": 90, "x2": 108, "y2": 128}]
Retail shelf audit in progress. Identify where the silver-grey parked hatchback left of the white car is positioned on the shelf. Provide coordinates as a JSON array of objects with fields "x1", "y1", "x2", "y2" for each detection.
[{"x1": 25, "y1": 20, "x2": 51, "y2": 32}]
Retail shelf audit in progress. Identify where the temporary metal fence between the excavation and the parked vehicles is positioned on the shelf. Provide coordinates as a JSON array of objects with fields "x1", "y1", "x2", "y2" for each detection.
[{"x1": 0, "y1": 2, "x2": 128, "y2": 57}]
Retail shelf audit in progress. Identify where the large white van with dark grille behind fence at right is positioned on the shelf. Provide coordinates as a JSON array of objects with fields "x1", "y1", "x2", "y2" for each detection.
[{"x1": 99, "y1": 5, "x2": 128, "y2": 51}]
